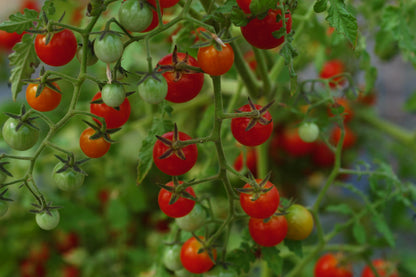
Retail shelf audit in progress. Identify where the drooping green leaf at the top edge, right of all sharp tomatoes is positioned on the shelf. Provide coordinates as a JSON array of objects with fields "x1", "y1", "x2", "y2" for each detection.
[{"x1": 326, "y1": 0, "x2": 358, "y2": 48}]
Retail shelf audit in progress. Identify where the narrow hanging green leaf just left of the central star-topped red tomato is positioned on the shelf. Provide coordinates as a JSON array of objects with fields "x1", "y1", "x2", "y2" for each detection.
[{"x1": 136, "y1": 118, "x2": 173, "y2": 184}]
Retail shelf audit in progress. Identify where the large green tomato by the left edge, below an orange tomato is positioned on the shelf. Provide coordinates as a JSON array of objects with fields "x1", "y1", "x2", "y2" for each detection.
[{"x1": 2, "y1": 118, "x2": 39, "y2": 151}]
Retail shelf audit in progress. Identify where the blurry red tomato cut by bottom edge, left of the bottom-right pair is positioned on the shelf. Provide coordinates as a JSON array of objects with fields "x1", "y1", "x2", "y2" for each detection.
[{"x1": 314, "y1": 253, "x2": 353, "y2": 277}]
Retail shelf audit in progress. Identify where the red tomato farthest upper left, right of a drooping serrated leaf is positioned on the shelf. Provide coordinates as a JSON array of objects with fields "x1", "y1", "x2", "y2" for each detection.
[{"x1": 35, "y1": 29, "x2": 77, "y2": 66}]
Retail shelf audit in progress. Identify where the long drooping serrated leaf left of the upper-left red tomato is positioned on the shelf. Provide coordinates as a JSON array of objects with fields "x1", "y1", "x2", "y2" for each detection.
[{"x1": 9, "y1": 34, "x2": 39, "y2": 101}]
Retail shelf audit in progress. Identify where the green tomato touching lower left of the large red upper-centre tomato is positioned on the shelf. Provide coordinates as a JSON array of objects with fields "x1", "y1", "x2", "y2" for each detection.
[{"x1": 138, "y1": 76, "x2": 168, "y2": 104}]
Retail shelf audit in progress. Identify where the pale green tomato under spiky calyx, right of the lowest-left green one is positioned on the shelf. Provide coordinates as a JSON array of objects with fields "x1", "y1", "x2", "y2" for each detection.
[{"x1": 52, "y1": 162, "x2": 85, "y2": 191}]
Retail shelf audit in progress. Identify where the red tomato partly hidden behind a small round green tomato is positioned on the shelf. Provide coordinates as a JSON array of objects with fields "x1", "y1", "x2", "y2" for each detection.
[{"x1": 90, "y1": 92, "x2": 131, "y2": 129}]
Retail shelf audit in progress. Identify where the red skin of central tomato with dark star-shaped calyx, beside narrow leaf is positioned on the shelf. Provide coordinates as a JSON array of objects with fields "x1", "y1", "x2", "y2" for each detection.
[{"x1": 153, "y1": 132, "x2": 198, "y2": 176}]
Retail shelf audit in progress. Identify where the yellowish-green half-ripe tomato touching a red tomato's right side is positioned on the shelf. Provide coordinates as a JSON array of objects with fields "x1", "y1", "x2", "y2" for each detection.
[{"x1": 285, "y1": 204, "x2": 314, "y2": 240}]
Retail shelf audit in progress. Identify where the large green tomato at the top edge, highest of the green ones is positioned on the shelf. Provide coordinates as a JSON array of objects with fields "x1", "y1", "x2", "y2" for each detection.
[{"x1": 118, "y1": 0, "x2": 153, "y2": 32}]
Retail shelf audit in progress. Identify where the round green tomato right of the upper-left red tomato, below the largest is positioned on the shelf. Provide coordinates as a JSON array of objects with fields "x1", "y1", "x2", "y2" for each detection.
[{"x1": 94, "y1": 33, "x2": 124, "y2": 63}]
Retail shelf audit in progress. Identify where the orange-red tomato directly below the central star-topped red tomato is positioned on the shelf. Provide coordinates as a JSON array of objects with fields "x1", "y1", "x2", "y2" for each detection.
[{"x1": 157, "y1": 181, "x2": 195, "y2": 218}]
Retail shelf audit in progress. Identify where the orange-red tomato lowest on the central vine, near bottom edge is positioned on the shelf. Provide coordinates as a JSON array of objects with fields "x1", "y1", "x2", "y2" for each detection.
[{"x1": 181, "y1": 236, "x2": 217, "y2": 274}]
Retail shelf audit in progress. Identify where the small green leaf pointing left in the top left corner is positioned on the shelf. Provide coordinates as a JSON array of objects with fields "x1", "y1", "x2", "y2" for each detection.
[{"x1": 0, "y1": 9, "x2": 38, "y2": 34}]
